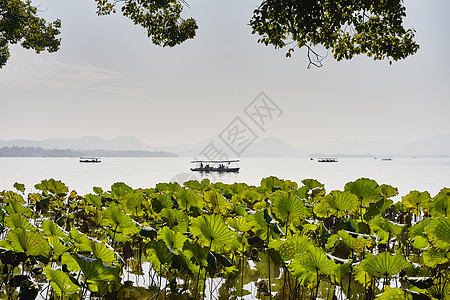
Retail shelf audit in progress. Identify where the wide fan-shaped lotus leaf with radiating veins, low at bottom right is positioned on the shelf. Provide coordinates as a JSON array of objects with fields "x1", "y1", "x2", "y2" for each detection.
[{"x1": 361, "y1": 252, "x2": 411, "y2": 278}]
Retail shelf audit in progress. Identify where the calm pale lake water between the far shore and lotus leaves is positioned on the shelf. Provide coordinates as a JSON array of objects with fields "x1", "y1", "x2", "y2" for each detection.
[{"x1": 0, "y1": 157, "x2": 450, "y2": 196}]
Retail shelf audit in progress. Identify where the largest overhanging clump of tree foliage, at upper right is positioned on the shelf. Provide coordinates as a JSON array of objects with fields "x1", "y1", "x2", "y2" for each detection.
[{"x1": 250, "y1": 0, "x2": 419, "y2": 66}]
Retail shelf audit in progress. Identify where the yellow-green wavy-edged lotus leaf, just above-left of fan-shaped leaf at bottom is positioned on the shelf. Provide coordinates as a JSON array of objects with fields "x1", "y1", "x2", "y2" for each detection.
[{"x1": 269, "y1": 233, "x2": 313, "y2": 262}]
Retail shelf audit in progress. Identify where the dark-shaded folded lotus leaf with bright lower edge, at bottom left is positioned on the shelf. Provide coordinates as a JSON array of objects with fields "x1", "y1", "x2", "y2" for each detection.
[{"x1": 73, "y1": 254, "x2": 120, "y2": 282}]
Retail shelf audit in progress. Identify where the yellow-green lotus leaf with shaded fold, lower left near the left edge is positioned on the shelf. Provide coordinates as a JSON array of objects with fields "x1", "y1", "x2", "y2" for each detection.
[{"x1": 7, "y1": 228, "x2": 51, "y2": 257}]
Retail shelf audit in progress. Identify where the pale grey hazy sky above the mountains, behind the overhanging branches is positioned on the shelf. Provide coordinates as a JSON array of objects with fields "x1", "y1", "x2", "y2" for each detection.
[{"x1": 0, "y1": 0, "x2": 450, "y2": 147}]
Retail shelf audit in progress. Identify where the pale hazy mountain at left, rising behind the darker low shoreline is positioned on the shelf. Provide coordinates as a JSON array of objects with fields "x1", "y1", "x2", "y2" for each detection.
[{"x1": 0, "y1": 136, "x2": 157, "y2": 151}]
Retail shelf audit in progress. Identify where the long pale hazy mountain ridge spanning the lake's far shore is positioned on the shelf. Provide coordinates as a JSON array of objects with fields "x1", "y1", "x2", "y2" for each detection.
[{"x1": 0, "y1": 133, "x2": 450, "y2": 157}]
